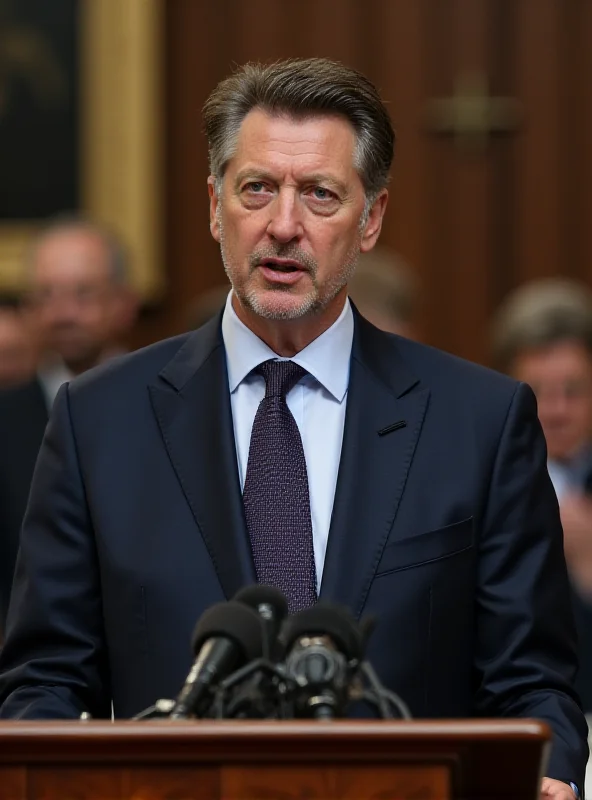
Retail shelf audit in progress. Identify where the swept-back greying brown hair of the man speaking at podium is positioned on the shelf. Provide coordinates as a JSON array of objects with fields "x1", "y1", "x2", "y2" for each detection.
[{"x1": 203, "y1": 58, "x2": 395, "y2": 206}]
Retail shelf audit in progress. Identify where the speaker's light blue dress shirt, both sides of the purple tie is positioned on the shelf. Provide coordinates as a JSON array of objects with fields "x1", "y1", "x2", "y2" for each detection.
[{"x1": 222, "y1": 292, "x2": 354, "y2": 590}]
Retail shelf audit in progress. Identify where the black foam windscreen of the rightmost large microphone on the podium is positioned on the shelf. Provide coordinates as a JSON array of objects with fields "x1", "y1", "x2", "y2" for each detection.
[{"x1": 281, "y1": 600, "x2": 364, "y2": 659}]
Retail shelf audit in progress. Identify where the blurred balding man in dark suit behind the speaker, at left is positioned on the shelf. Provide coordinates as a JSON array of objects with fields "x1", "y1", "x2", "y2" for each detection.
[{"x1": 0, "y1": 219, "x2": 137, "y2": 631}]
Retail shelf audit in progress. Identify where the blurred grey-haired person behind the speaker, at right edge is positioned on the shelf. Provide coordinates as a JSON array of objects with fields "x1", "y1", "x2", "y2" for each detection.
[{"x1": 493, "y1": 279, "x2": 592, "y2": 712}]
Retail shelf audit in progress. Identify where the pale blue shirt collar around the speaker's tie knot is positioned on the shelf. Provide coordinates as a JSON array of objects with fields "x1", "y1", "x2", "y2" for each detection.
[{"x1": 222, "y1": 292, "x2": 354, "y2": 403}]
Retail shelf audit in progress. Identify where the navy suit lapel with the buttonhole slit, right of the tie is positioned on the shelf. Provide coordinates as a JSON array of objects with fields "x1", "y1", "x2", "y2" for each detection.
[{"x1": 321, "y1": 314, "x2": 429, "y2": 615}]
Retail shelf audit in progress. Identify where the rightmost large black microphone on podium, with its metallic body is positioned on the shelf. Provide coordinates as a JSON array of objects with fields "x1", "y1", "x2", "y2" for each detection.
[{"x1": 280, "y1": 600, "x2": 364, "y2": 719}]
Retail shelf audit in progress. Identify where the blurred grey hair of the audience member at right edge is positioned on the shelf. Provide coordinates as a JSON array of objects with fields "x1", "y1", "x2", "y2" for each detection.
[{"x1": 491, "y1": 278, "x2": 592, "y2": 370}]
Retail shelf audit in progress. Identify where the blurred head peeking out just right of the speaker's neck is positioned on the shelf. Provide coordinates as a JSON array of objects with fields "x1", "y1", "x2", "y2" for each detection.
[{"x1": 349, "y1": 245, "x2": 418, "y2": 338}]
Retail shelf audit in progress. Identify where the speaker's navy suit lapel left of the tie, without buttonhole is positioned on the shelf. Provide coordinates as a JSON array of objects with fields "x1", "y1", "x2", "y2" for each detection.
[{"x1": 149, "y1": 317, "x2": 255, "y2": 598}]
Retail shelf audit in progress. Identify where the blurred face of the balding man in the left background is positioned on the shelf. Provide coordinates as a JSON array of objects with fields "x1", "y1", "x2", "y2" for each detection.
[{"x1": 30, "y1": 227, "x2": 131, "y2": 373}]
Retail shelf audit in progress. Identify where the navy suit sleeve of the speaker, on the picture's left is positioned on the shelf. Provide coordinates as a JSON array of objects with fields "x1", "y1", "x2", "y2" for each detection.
[{"x1": 0, "y1": 385, "x2": 111, "y2": 719}]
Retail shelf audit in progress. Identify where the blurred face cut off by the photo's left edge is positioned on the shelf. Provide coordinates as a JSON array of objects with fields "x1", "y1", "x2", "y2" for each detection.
[{"x1": 0, "y1": 295, "x2": 37, "y2": 389}]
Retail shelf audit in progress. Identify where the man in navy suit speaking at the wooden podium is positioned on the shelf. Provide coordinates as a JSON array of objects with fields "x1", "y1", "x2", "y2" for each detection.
[{"x1": 0, "y1": 59, "x2": 587, "y2": 800}]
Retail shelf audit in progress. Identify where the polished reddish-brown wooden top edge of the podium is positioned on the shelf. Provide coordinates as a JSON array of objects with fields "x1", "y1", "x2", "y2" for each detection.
[{"x1": 0, "y1": 719, "x2": 551, "y2": 769}]
